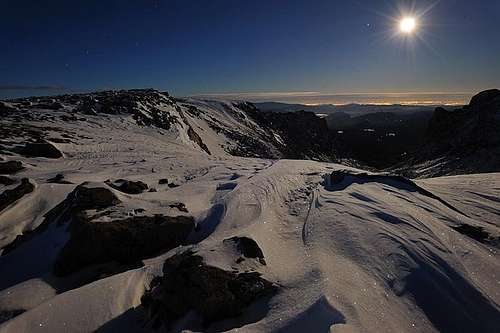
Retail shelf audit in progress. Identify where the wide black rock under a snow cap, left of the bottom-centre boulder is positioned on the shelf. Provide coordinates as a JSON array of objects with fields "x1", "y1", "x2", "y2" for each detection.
[{"x1": 54, "y1": 215, "x2": 194, "y2": 276}]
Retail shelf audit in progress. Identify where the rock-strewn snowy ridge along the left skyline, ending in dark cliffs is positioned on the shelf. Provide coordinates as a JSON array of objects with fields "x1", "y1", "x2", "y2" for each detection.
[{"x1": 0, "y1": 89, "x2": 335, "y2": 161}]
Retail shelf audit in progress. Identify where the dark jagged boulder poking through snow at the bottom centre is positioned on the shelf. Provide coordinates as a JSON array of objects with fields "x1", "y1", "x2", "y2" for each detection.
[{"x1": 141, "y1": 252, "x2": 277, "y2": 328}]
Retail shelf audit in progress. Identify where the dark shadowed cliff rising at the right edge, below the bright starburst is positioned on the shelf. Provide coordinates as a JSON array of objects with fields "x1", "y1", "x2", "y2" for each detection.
[{"x1": 398, "y1": 89, "x2": 500, "y2": 176}]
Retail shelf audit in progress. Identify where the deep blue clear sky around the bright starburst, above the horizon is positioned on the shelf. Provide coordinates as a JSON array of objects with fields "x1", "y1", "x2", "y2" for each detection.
[{"x1": 0, "y1": 0, "x2": 500, "y2": 97}]
